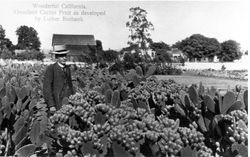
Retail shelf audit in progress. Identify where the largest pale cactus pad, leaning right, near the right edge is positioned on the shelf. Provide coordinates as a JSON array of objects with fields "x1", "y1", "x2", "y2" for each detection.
[{"x1": 220, "y1": 91, "x2": 235, "y2": 114}]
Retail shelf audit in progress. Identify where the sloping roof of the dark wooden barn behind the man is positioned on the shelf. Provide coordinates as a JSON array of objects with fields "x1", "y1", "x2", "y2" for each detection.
[{"x1": 52, "y1": 34, "x2": 96, "y2": 46}]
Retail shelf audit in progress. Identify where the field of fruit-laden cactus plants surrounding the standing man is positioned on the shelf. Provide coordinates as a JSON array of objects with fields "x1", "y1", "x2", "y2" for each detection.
[{"x1": 0, "y1": 64, "x2": 248, "y2": 157}]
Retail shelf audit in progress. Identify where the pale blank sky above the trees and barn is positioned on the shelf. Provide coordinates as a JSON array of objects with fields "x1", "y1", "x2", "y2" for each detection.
[{"x1": 0, "y1": 0, "x2": 250, "y2": 50}]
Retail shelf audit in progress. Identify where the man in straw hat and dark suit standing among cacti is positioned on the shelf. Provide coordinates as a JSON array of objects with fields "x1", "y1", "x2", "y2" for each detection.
[{"x1": 43, "y1": 45, "x2": 74, "y2": 114}]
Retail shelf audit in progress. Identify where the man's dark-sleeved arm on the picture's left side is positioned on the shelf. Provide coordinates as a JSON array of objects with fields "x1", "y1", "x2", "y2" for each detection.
[{"x1": 43, "y1": 66, "x2": 55, "y2": 108}]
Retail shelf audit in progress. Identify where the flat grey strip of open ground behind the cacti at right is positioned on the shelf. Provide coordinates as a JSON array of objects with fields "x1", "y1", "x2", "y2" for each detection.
[{"x1": 156, "y1": 75, "x2": 248, "y2": 90}]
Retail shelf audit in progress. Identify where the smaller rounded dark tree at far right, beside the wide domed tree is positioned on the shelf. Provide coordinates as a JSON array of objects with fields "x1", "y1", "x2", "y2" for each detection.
[{"x1": 218, "y1": 40, "x2": 242, "y2": 62}]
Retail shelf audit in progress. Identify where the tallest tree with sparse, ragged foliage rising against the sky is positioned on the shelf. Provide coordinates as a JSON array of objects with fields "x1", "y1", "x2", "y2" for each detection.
[{"x1": 126, "y1": 7, "x2": 154, "y2": 59}]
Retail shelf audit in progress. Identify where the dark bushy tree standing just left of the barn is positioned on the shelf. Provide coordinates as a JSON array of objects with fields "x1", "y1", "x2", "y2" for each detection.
[{"x1": 16, "y1": 25, "x2": 41, "y2": 50}]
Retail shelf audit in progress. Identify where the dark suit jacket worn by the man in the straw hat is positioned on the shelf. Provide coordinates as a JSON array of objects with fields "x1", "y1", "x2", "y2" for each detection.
[{"x1": 43, "y1": 63, "x2": 74, "y2": 110}]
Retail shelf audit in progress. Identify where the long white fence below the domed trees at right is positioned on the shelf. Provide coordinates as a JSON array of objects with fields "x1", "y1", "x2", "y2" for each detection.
[{"x1": 181, "y1": 62, "x2": 248, "y2": 70}]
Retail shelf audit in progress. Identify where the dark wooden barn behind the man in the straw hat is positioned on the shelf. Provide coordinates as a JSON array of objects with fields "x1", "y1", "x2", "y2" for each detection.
[{"x1": 52, "y1": 34, "x2": 96, "y2": 61}]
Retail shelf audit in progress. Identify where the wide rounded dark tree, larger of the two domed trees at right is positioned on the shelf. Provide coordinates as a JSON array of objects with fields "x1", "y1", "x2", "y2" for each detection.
[{"x1": 173, "y1": 34, "x2": 220, "y2": 59}]
